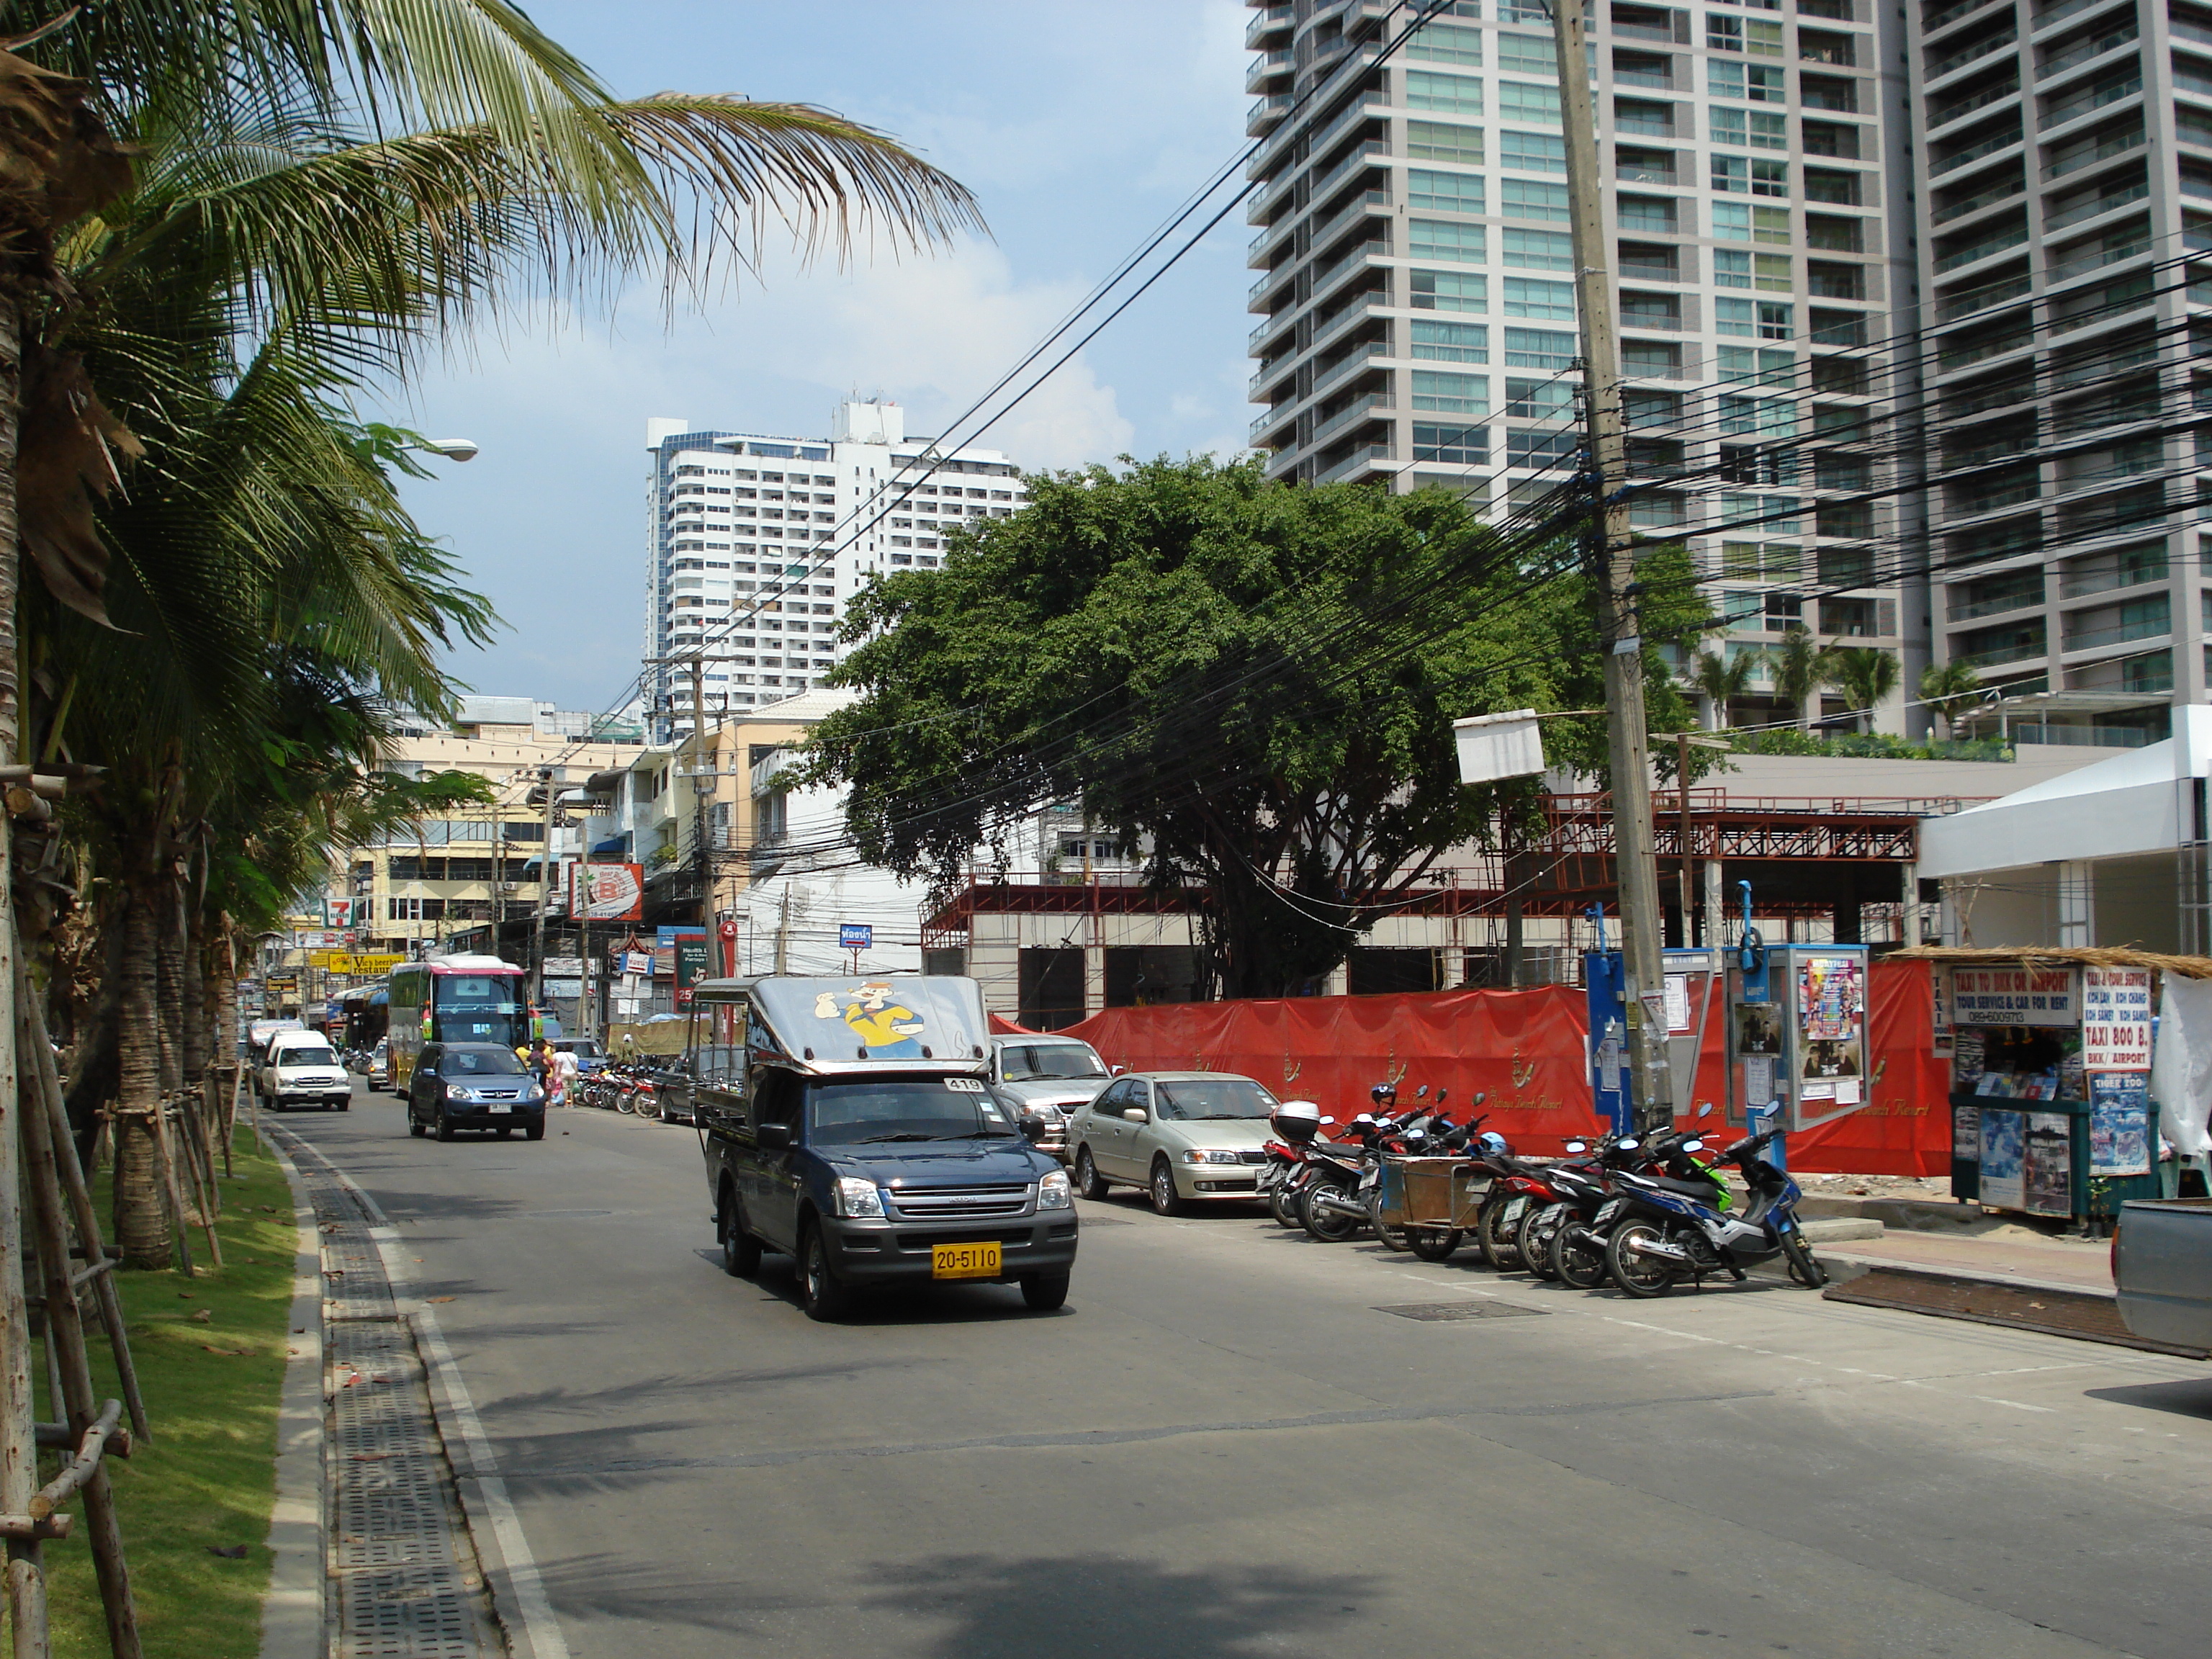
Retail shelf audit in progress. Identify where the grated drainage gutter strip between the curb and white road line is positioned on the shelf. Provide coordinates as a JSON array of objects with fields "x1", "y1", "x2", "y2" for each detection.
[{"x1": 272, "y1": 1126, "x2": 504, "y2": 1659}]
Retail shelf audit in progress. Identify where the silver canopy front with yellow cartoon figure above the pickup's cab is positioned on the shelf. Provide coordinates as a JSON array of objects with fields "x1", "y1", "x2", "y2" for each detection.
[{"x1": 693, "y1": 974, "x2": 989, "y2": 1071}]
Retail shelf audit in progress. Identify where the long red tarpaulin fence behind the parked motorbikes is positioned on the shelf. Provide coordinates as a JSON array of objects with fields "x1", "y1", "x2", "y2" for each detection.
[{"x1": 1061, "y1": 962, "x2": 1951, "y2": 1174}]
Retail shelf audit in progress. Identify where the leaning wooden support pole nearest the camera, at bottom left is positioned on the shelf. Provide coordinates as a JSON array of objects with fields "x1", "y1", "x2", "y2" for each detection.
[{"x1": 16, "y1": 981, "x2": 140, "y2": 1659}]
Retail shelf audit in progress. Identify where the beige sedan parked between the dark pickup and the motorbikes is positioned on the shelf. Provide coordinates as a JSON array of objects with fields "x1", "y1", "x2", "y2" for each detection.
[{"x1": 1069, "y1": 1071, "x2": 1279, "y2": 1215}]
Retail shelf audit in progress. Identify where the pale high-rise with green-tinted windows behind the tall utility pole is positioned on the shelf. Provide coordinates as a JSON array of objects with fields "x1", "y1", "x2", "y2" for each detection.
[{"x1": 1248, "y1": 0, "x2": 1925, "y2": 734}]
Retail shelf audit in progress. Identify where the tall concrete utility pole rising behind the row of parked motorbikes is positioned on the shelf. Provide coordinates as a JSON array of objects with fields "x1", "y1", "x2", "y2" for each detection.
[{"x1": 1550, "y1": 0, "x2": 1675, "y2": 1128}]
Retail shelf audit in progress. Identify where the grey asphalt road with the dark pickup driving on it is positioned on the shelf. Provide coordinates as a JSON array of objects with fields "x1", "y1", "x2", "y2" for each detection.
[{"x1": 285, "y1": 1095, "x2": 2212, "y2": 1659}]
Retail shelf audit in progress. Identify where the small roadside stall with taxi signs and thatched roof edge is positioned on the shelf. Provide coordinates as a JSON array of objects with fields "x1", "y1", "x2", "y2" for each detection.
[{"x1": 1898, "y1": 945, "x2": 2176, "y2": 1223}]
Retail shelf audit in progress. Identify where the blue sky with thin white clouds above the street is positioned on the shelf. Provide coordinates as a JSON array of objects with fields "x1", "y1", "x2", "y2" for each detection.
[{"x1": 374, "y1": 0, "x2": 1250, "y2": 708}]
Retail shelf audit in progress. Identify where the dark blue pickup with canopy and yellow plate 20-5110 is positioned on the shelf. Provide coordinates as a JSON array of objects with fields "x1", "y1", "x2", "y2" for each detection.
[{"x1": 693, "y1": 976, "x2": 1077, "y2": 1321}]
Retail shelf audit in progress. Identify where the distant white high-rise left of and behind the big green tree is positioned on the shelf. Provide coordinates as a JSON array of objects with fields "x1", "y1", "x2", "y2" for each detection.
[{"x1": 646, "y1": 403, "x2": 1026, "y2": 737}]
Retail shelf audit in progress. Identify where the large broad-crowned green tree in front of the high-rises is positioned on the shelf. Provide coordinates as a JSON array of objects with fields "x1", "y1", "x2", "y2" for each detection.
[{"x1": 814, "y1": 460, "x2": 1703, "y2": 995}]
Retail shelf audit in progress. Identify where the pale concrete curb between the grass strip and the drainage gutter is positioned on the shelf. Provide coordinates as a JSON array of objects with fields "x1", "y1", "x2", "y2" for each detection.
[{"x1": 254, "y1": 1124, "x2": 330, "y2": 1659}]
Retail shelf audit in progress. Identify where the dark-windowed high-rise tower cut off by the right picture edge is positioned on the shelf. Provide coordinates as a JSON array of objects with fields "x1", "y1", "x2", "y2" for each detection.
[{"x1": 1911, "y1": 0, "x2": 2212, "y2": 743}]
